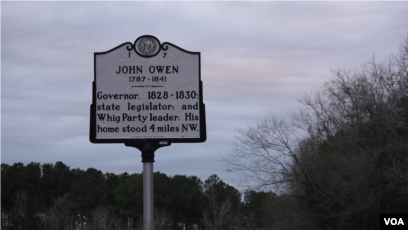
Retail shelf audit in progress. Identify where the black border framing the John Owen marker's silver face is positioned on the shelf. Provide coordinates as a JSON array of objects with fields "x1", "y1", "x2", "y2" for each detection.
[{"x1": 89, "y1": 35, "x2": 207, "y2": 145}]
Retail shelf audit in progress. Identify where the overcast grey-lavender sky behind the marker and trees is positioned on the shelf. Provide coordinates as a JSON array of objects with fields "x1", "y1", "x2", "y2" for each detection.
[{"x1": 0, "y1": 0, "x2": 408, "y2": 187}]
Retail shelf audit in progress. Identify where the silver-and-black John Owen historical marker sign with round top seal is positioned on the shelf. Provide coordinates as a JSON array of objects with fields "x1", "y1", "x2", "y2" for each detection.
[{"x1": 90, "y1": 35, "x2": 206, "y2": 144}]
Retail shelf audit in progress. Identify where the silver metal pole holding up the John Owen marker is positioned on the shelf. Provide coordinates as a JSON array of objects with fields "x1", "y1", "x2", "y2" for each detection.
[{"x1": 143, "y1": 162, "x2": 154, "y2": 230}]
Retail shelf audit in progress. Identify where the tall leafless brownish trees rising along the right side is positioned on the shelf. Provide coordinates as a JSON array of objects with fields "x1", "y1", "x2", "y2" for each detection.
[{"x1": 224, "y1": 34, "x2": 408, "y2": 230}]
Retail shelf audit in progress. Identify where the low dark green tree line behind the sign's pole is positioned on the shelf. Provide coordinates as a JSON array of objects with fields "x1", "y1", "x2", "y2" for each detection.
[{"x1": 0, "y1": 162, "x2": 275, "y2": 230}]
